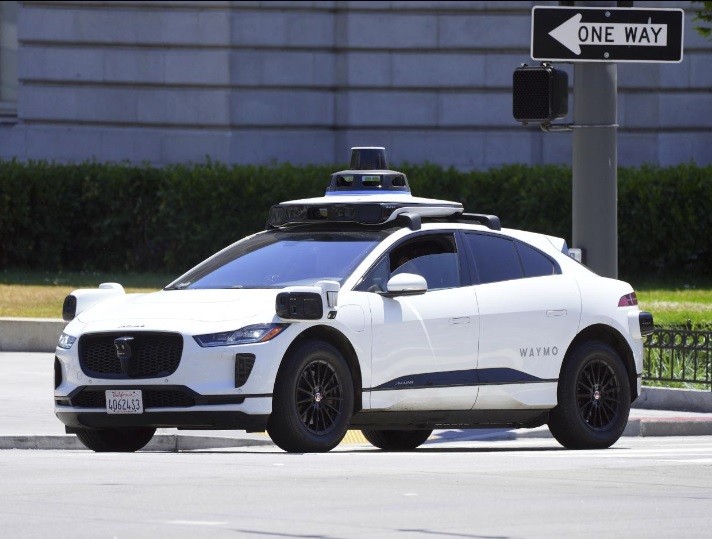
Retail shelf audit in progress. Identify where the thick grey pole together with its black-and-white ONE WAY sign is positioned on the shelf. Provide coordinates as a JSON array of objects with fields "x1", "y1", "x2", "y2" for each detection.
[{"x1": 524, "y1": 0, "x2": 685, "y2": 277}]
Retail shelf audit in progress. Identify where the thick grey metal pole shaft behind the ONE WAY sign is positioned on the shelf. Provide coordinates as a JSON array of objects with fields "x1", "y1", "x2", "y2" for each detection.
[{"x1": 572, "y1": 2, "x2": 618, "y2": 278}]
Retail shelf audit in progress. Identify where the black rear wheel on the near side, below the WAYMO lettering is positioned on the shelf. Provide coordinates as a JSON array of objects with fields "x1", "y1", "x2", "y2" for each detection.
[{"x1": 549, "y1": 341, "x2": 631, "y2": 449}]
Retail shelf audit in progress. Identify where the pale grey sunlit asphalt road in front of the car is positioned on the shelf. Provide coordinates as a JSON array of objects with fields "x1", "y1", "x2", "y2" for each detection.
[{"x1": 0, "y1": 437, "x2": 712, "y2": 539}]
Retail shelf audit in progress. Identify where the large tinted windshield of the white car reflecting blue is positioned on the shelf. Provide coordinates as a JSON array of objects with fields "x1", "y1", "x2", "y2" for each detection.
[{"x1": 166, "y1": 230, "x2": 387, "y2": 290}]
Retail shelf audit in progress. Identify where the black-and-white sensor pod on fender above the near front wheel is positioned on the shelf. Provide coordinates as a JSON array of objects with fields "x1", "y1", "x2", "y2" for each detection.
[{"x1": 275, "y1": 281, "x2": 341, "y2": 320}]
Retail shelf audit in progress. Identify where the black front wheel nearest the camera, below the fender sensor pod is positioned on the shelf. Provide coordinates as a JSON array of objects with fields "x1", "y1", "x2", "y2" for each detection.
[{"x1": 267, "y1": 340, "x2": 354, "y2": 453}]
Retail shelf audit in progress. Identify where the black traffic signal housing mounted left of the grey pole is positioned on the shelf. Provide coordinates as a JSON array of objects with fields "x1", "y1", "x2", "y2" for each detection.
[{"x1": 512, "y1": 64, "x2": 569, "y2": 124}]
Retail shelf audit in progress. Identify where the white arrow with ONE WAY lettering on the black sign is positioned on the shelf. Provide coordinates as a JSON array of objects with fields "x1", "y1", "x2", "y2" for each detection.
[{"x1": 549, "y1": 13, "x2": 667, "y2": 55}]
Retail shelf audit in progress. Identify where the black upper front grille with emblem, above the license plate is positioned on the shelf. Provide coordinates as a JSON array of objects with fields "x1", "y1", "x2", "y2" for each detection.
[{"x1": 79, "y1": 332, "x2": 183, "y2": 379}]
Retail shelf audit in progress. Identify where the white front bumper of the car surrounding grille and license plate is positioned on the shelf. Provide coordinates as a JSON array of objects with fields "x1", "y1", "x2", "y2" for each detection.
[{"x1": 54, "y1": 322, "x2": 290, "y2": 436}]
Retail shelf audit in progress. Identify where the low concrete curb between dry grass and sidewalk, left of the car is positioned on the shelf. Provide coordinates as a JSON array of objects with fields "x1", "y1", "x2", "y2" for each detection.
[{"x1": 0, "y1": 318, "x2": 67, "y2": 352}]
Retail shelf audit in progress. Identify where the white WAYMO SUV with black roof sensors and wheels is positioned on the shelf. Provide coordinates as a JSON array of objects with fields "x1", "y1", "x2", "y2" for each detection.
[{"x1": 54, "y1": 148, "x2": 653, "y2": 452}]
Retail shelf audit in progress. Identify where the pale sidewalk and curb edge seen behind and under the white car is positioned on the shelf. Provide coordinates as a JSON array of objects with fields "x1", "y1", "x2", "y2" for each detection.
[{"x1": 0, "y1": 352, "x2": 712, "y2": 451}]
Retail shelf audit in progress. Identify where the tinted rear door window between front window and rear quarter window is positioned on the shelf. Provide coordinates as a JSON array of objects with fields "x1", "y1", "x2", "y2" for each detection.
[{"x1": 465, "y1": 234, "x2": 524, "y2": 284}]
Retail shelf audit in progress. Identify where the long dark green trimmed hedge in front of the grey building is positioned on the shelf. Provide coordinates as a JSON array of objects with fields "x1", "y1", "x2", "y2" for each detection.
[{"x1": 0, "y1": 161, "x2": 712, "y2": 279}]
